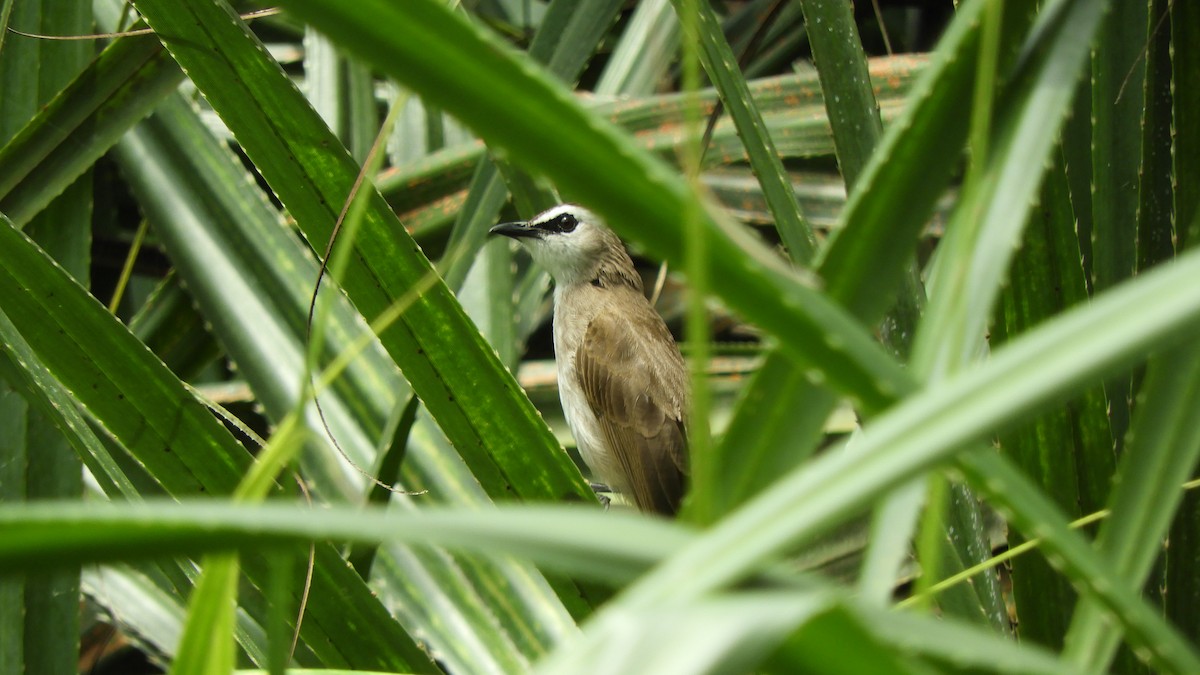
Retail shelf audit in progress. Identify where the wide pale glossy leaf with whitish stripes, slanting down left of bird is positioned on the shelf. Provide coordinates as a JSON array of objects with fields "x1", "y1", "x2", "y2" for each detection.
[{"x1": 118, "y1": 94, "x2": 571, "y2": 670}]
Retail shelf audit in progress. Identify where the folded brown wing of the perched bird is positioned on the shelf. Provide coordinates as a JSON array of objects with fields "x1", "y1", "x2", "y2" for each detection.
[{"x1": 575, "y1": 296, "x2": 689, "y2": 515}]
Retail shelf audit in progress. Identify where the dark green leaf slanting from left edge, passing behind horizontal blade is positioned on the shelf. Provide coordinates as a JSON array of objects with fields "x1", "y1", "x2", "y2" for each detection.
[{"x1": 0, "y1": 213, "x2": 436, "y2": 667}]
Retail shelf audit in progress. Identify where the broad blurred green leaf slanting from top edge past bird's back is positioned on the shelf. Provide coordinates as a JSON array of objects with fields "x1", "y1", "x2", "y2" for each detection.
[{"x1": 278, "y1": 0, "x2": 900, "y2": 410}]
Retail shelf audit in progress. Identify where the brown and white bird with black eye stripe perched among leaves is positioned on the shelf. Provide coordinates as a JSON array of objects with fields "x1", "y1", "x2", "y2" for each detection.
[{"x1": 490, "y1": 204, "x2": 691, "y2": 516}]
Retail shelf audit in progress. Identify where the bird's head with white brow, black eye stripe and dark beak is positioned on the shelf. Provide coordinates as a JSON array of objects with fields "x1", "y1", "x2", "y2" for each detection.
[{"x1": 488, "y1": 204, "x2": 632, "y2": 286}]
